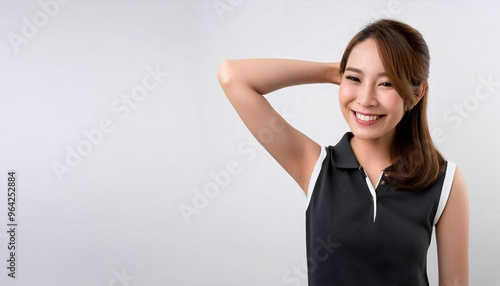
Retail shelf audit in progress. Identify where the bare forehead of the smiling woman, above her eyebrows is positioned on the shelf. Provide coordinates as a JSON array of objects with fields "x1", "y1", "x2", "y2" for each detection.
[{"x1": 347, "y1": 39, "x2": 384, "y2": 73}]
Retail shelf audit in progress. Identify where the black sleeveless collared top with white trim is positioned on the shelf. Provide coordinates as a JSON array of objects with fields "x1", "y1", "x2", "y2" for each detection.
[{"x1": 306, "y1": 133, "x2": 455, "y2": 286}]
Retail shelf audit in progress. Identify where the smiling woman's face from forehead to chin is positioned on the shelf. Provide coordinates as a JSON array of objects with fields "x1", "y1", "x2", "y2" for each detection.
[{"x1": 339, "y1": 39, "x2": 404, "y2": 142}]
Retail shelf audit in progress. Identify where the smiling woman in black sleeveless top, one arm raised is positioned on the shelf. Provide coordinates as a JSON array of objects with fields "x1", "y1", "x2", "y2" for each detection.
[{"x1": 218, "y1": 20, "x2": 469, "y2": 286}]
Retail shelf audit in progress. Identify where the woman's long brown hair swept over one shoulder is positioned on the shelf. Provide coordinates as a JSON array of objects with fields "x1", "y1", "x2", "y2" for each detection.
[{"x1": 340, "y1": 19, "x2": 445, "y2": 191}]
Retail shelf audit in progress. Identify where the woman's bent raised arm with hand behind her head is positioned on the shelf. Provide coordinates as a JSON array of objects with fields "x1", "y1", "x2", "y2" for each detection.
[{"x1": 218, "y1": 59, "x2": 340, "y2": 193}]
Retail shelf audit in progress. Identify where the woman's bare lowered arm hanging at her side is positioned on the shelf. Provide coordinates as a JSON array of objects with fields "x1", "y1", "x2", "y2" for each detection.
[{"x1": 436, "y1": 168, "x2": 469, "y2": 286}]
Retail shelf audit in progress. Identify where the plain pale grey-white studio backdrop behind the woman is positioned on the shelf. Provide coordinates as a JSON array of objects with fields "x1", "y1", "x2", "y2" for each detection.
[{"x1": 0, "y1": 0, "x2": 500, "y2": 286}]
